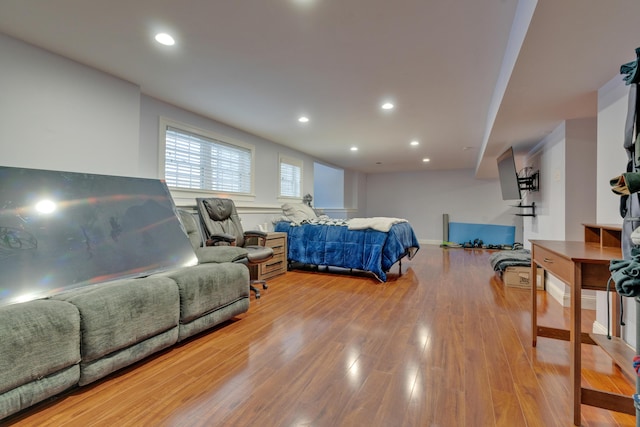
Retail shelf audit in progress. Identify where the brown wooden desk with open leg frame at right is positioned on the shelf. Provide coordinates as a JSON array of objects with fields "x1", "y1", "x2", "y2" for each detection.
[{"x1": 531, "y1": 240, "x2": 635, "y2": 426}]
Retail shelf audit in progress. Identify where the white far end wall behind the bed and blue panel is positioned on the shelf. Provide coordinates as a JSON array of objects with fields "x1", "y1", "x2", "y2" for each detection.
[{"x1": 364, "y1": 169, "x2": 522, "y2": 243}]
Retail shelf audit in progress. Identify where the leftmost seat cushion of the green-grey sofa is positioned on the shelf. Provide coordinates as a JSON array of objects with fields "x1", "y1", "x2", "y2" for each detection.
[{"x1": 0, "y1": 300, "x2": 80, "y2": 398}]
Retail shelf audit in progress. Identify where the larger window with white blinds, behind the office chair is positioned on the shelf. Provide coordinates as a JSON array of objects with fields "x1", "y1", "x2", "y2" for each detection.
[{"x1": 160, "y1": 119, "x2": 254, "y2": 194}]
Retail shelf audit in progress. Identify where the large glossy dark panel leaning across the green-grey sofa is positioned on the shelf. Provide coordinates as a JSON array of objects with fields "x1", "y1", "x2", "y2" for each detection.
[{"x1": 0, "y1": 167, "x2": 195, "y2": 305}]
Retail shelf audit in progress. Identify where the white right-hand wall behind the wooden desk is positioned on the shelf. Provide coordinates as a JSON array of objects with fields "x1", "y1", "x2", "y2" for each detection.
[{"x1": 524, "y1": 76, "x2": 636, "y2": 345}]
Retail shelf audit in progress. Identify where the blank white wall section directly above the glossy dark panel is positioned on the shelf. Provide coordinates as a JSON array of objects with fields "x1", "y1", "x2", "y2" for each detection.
[{"x1": 0, "y1": 34, "x2": 142, "y2": 176}]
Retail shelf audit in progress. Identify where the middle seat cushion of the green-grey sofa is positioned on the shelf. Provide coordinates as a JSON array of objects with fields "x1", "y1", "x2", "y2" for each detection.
[{"x1": 51, "y1": 276, "x2": 180, "y2": 364}]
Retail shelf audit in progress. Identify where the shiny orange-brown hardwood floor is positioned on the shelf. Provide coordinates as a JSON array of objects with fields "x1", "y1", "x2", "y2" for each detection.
[{"x1": 0, "y1": 245, "x2": 635, "y2": 427}]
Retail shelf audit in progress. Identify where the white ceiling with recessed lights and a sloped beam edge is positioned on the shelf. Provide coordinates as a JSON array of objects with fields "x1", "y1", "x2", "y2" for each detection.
[{"x1": 0, "y1": 0, "x2": 640, "y2": 178}]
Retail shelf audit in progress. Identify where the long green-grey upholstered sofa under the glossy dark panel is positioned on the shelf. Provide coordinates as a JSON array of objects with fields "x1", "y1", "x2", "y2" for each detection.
[{"x1": 0, "y1": 212, "x2": 250, "y2": 420}]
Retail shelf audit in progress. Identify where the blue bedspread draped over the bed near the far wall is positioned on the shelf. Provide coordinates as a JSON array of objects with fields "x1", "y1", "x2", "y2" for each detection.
[{"x1": 275, "y1": 222, "x2": 420, "y2": 282}]
